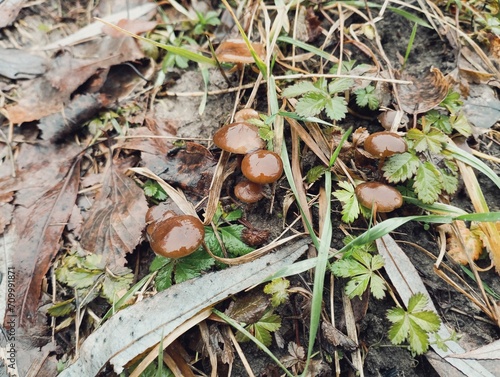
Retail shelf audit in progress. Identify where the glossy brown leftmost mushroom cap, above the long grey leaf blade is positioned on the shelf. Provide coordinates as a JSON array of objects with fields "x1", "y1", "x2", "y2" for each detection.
[{"x1": 150, "y1": 215, "x2": 205, "y2": 258}]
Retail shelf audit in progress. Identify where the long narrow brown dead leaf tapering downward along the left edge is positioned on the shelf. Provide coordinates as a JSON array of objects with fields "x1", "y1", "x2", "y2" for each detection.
[{"x1": 12, "y1": 162, "x2": 80, "y2": 325}]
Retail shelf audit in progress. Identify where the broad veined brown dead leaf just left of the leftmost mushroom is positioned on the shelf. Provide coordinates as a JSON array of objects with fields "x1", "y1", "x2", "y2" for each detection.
[{"x1": 81, "y1": 156, "x2": 148, "y2": 268}]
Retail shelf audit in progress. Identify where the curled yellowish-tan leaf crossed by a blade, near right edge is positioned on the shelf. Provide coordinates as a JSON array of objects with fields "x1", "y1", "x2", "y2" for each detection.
[{"x1": 438, "y1": 220, "x2": 483, "y2": 265}]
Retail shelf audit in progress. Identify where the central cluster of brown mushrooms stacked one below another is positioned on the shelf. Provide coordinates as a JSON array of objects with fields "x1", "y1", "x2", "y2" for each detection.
[{"x1": 213, "y1": 109, "x2": 283, "y2": 203}]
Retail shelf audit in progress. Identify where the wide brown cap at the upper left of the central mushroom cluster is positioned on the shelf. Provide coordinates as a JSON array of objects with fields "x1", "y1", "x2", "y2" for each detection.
[{"x1": 214, "y1": 122, "x2": 266, "y2": 154}]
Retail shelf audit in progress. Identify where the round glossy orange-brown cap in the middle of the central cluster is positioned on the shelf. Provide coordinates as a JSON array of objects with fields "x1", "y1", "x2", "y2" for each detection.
[{"x1": 241, "y1": 149, "x2": 283, "y2": 185}]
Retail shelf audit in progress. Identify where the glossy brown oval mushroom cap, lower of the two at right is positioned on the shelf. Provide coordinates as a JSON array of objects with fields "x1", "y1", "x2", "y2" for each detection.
[{"x1": 354, "y1": 182, "x2": 403, "y2": 212}]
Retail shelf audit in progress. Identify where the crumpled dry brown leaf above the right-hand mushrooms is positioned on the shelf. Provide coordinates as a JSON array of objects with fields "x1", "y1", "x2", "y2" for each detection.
[{"x1": 398, "y1": 68, "x2": 449, "y2": 114}]
